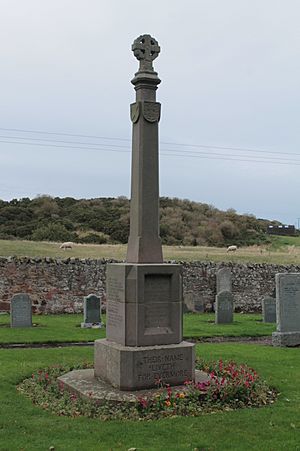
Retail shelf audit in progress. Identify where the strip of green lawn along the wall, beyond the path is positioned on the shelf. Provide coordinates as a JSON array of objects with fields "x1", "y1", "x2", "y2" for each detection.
[{"x1": 0, "y1": 313, "x2": 275, "y2": 346}]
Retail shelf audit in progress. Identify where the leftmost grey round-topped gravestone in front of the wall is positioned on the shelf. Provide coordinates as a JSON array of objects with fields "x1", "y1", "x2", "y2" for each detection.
[{"x1": 10, "y1": 293, "x2": 32, "y2": 327}]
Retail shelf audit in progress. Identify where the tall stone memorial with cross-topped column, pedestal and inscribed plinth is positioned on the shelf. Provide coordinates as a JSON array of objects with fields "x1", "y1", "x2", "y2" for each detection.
[{"x1": 95, "y1": 35, "x2": 195, "y2": 390}]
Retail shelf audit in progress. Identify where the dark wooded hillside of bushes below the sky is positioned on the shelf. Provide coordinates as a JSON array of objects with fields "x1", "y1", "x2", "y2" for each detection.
[{"x1": 0, "y1": 196, "x2": 280, "y2": 247}]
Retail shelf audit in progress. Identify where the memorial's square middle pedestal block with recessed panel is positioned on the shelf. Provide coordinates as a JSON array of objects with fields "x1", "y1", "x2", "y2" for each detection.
[{"x1": 106, "y1": 263, "x2": 182, "y2": 346}]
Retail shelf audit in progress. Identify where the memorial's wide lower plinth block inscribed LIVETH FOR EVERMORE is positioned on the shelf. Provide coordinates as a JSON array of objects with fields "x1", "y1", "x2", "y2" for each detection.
[{"x1": 94, "y1": 339, "x2": 195, "y2": 390}]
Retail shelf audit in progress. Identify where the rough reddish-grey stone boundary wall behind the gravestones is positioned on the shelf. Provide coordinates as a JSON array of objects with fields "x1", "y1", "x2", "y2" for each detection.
[{"x1": 0, "y1": 257, "x2": 300, "y2": 313}]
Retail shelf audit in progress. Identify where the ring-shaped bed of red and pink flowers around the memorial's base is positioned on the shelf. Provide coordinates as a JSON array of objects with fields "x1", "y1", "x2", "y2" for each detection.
[{"x1": 18, "y1": 360, "x2": 276, "y2": 420}]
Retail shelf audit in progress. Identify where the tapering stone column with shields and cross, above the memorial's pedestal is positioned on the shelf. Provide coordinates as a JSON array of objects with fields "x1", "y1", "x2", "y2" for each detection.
[{"x1": 126, "y1": 35, "x2": 163, "y2": 263}]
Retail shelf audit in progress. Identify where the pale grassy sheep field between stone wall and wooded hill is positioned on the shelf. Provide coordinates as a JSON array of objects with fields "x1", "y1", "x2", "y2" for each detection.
[{"x1": 0, "y1": 236, "x2": 300, "y2": 264}]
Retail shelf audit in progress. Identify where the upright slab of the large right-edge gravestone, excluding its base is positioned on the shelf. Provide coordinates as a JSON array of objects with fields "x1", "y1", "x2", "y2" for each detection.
[{"x1": 276, "y1": 274, "x2": 300, "y2": 332}]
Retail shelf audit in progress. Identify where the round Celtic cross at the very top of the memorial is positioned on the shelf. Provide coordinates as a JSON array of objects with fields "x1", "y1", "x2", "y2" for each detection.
[{"x1": 131, "y1": 34, "x2": 160, "y2": 71}]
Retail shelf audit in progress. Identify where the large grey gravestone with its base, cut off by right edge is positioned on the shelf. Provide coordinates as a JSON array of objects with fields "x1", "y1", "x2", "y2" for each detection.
[{"x1": 272, "y1": 273, "x2": 300, "y2": 346}]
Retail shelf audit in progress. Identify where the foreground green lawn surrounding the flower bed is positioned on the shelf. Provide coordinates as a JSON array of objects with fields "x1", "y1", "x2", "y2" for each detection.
[{"x1": 0, "y1": 343, "x2": 300, "y2": 451}]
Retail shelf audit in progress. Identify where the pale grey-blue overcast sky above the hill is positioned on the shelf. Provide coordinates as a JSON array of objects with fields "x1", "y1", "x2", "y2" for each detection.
[{"x1": 0, "y1": 0, "x2": 300, "y2": 224}]
